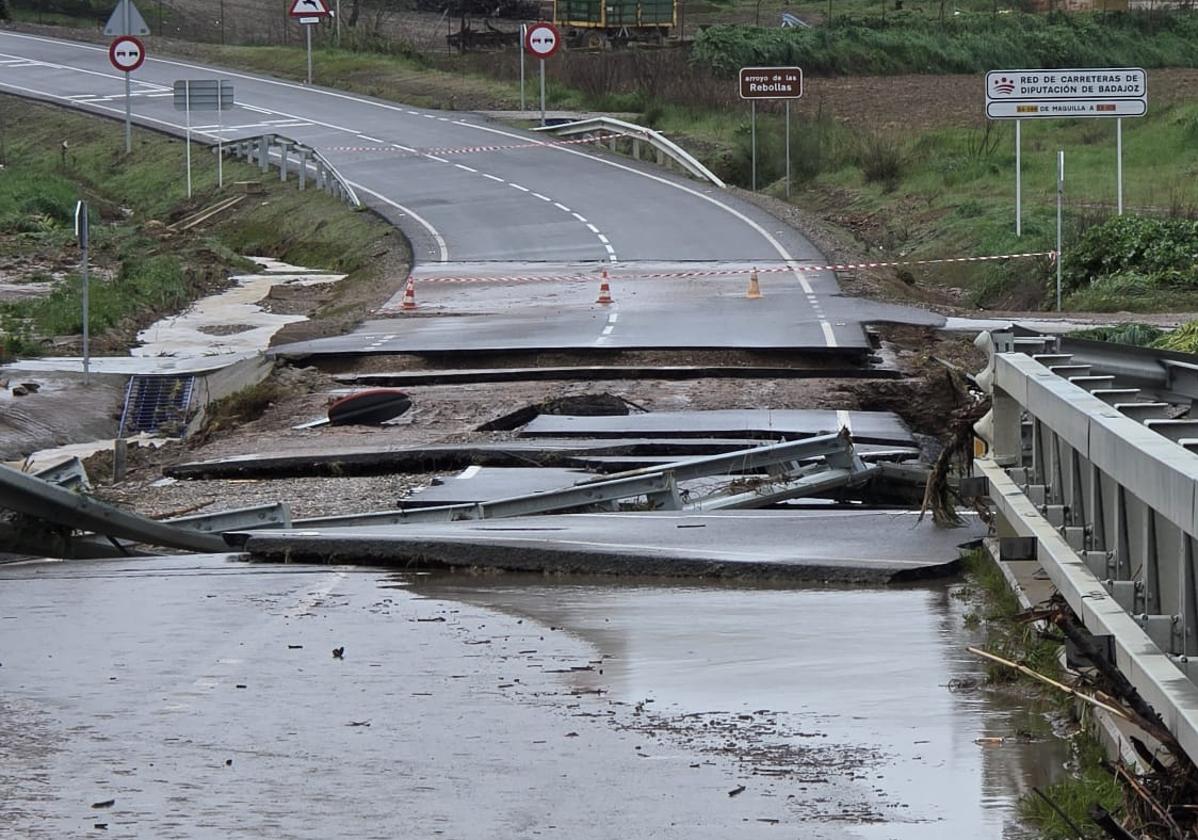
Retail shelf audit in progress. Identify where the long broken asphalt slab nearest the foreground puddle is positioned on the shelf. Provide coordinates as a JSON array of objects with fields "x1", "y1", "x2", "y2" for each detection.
[{"x1": 225, "y1": 510, "x2": 985, "y2": 584}]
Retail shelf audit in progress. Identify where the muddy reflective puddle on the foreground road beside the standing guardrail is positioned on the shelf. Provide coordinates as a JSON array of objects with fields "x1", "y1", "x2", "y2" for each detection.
[{"x1": 413, "y1": 576, "x2": 1070, "y2": 840}]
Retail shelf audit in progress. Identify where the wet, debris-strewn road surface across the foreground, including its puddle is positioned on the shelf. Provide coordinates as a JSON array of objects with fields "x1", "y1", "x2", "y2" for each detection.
[{"x1": 0, "y1": 556, "x2": 1065, "y2": 839}]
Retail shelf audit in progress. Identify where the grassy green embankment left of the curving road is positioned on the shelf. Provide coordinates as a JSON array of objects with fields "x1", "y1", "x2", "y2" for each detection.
[{"x1": 0, "y1": 97, "x2": 391, "y2": 361}]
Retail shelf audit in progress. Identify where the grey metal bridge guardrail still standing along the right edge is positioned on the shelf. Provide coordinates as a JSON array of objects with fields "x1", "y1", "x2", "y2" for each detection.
[{"x1": 974, "y1": 332, "x2": 1198, "y2": 760}]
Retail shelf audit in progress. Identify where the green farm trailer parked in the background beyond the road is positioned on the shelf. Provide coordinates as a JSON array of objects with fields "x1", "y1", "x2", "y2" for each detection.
[{"x1": 553, "y1": 0, "x2": 678, "y2": 48}]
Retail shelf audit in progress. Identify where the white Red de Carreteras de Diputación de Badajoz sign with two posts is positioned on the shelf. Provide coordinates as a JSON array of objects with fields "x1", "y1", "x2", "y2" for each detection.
[{"x1": 986, "y1": 67, "x2": 1148, "y2": 236}]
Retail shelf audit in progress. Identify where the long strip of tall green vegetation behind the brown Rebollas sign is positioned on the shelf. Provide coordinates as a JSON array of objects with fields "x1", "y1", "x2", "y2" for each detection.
[{"x1": 694, "y1": 12, "x2": 1198, "y2": 75}]
